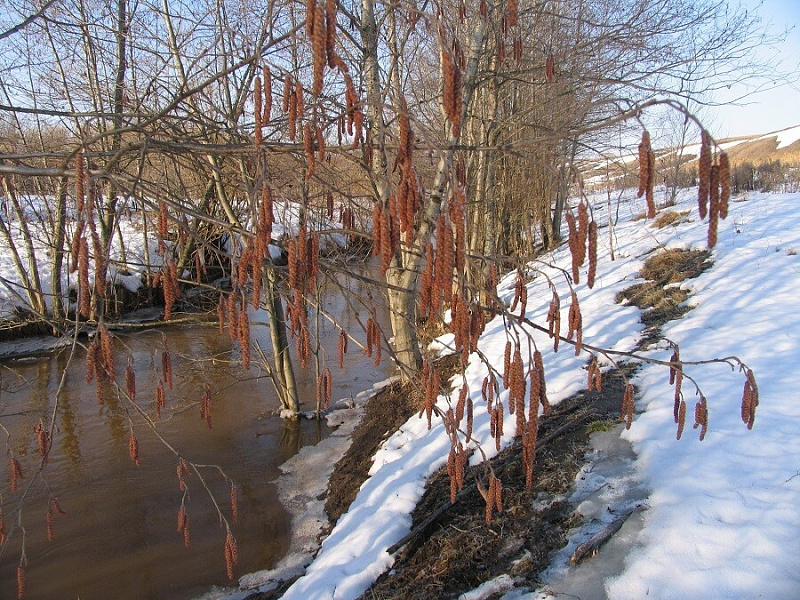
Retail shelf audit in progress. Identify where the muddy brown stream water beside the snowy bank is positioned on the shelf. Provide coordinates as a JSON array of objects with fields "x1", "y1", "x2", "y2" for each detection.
[{"x1": 0, "y1": 266, "x2": 389, "y2": 600}]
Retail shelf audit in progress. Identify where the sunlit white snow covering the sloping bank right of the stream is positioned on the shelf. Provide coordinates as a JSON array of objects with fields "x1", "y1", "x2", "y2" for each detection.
[{"x1": 238, "y1": 190, "x2": 800, "y2": 600}]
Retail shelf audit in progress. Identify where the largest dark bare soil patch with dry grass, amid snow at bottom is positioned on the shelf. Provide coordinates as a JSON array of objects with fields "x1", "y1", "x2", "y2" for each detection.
[{"x1": 363, "y1": 372, "x2": 624, "y2": 599}]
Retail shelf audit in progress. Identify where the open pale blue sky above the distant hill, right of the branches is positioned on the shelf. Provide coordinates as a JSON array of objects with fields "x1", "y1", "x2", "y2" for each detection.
[{"x1": 711, "y1": 0, "x2": 800, "y2": 137}]
